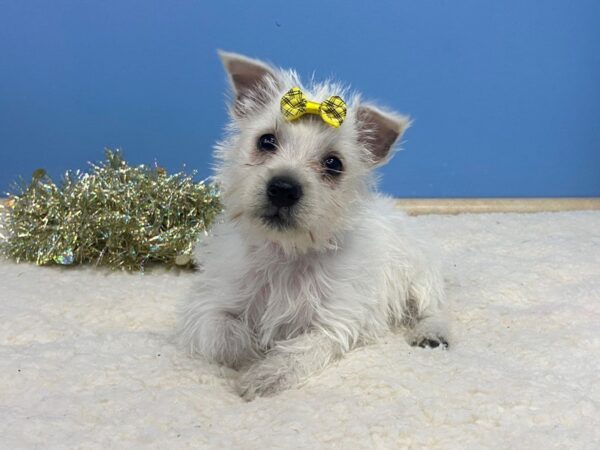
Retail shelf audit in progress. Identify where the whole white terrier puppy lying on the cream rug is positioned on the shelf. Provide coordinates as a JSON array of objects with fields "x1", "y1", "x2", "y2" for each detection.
[{"x1": 179, "y1": 53, "x2": 449, "y2": 400}]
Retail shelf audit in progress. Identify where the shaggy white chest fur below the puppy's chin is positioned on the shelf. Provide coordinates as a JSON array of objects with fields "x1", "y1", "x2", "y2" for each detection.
[{"x1": 238, "y1": 250, "x2": 329, "y2": 348}]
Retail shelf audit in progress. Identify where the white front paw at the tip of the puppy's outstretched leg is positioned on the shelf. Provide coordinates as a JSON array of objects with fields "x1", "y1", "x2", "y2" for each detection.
[{"x1": 237, "y1": 356, "x2": 296, "y2": 401}]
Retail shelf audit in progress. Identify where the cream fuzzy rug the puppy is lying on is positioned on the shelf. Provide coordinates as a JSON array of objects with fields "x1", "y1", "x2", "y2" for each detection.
[{"x1": 0, "y1": 212, "x2": 600, "y2": 449}]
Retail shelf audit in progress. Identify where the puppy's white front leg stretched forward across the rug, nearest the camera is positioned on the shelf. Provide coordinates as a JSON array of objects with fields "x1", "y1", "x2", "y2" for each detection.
[{"x1": 238, "y1": 332, "x2": 343, "y2": 401}]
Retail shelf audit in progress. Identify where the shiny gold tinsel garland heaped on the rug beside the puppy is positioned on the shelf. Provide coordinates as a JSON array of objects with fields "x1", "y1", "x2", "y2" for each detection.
[{"x1": 0, "y1": 150, "x2": 221, "y2": 270}]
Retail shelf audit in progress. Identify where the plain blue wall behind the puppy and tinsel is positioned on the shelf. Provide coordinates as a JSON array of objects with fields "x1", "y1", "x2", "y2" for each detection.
[{"x1": 0, "y1": 0, "x2": 600, "y2": 197}]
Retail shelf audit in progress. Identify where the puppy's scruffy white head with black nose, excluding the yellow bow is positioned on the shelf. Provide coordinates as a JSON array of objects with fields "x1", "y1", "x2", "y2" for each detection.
[{"x1": 216, "y1": 52, "x2": 409, "y2": 253}]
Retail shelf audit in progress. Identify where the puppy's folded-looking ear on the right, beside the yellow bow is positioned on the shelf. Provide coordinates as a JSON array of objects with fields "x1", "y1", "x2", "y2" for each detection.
[{"x1": 356, "y1": 105, "x2": 410, "y2": 166}]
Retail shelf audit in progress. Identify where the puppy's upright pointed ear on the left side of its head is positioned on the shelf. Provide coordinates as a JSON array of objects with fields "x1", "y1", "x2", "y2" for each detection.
[{"x1": 218, "y1": 50, "x2": 277, "y2": 116}]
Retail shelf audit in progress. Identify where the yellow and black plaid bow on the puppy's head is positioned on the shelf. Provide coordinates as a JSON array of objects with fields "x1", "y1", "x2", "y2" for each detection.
[{"x1": 281, "y1": 87, "x2": 347, "y2": 128}]
